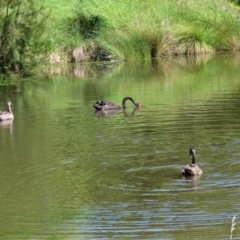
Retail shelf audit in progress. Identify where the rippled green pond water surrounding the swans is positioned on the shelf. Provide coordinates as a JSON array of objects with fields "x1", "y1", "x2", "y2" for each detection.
[{"x1": 0, "y1": 55, "x2": 240, "y2": 240}]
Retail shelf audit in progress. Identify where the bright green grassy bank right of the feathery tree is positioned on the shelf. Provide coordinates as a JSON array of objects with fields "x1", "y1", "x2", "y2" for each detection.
[{"x1": 45, "y1": 0, "x2": 240, "y2": 60}]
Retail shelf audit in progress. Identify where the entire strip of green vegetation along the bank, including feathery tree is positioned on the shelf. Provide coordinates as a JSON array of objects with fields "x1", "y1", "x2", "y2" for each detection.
[{"x1": 0, "y1": 0, "x2": 240, "y2": 78}]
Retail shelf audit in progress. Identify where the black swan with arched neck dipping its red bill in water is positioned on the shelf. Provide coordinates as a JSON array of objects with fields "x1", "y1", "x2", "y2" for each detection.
[{"x1": 93, "y1": 97, "x2": 141, "y2": 110}]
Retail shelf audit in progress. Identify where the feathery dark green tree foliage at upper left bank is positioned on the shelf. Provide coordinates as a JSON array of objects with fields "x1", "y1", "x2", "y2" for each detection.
[{"x1": 0, "y1": 0, "x2": 48, "y2": 74}]
